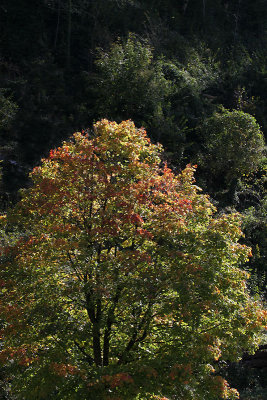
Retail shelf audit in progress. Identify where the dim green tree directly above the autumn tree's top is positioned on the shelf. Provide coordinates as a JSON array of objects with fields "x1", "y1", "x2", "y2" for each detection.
[{"x1": 91, "y1": 34, "x2": 172, "y2": 141}]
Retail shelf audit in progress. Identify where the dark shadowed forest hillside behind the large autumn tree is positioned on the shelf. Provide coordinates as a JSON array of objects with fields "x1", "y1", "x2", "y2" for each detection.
[{"x1": 0, "y1": 0, "x2": 267, "y2": 399}]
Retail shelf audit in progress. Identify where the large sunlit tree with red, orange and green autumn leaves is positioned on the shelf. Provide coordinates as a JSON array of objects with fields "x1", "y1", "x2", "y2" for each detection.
[{"x1": 0, "y1": 120, "x2": 266, "y2": 400}]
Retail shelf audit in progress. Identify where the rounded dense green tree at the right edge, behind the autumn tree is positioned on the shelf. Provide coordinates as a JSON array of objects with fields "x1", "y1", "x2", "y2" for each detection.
[{"x1": 200, "y1": 109, "x2": 265, "y2": 198}]
